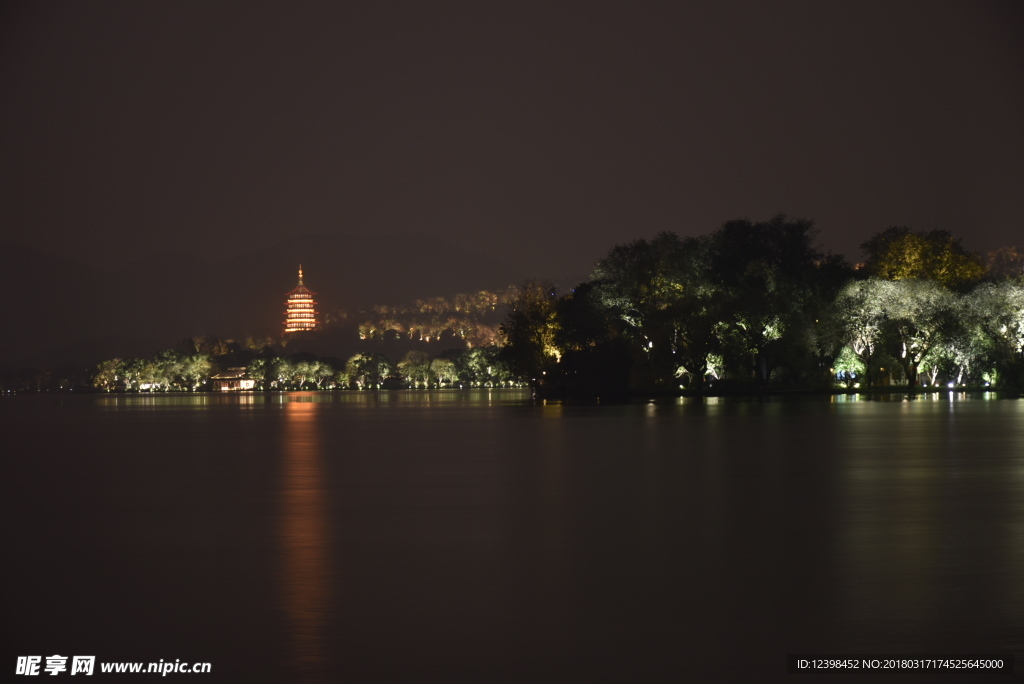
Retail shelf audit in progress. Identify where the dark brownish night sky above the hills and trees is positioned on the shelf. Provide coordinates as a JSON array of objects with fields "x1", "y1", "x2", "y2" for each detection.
[{"x1": 0, "y1": 0, "x2": 1024, "y2": 275}]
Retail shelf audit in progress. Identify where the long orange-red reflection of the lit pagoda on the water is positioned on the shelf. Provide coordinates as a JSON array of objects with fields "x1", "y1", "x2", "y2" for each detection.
[{"x1": 281, "y1": 401, "x2": 331, "y2": 682}]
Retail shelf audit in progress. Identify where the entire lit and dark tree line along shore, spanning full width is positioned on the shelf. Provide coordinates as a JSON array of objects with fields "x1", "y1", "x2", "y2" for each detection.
[{"x1": 3, "y1": 215, "x2": 1024, "y2": 396}]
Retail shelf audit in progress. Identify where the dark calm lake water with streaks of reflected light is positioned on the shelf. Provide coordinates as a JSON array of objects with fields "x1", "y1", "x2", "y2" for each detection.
[{"x1": 0, "y1": 391, "x2": 1024, "y2": 682}]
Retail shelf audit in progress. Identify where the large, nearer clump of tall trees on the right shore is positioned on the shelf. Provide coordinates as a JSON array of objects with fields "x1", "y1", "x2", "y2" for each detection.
[{"x1": 502, "y1": 215, "x2": 1024, "y2": 395}]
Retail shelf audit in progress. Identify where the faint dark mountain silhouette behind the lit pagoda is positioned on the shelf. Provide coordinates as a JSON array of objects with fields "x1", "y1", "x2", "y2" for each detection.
[{"x1": 0, "y1": 234, "x2": 540, "y2": 370}]
